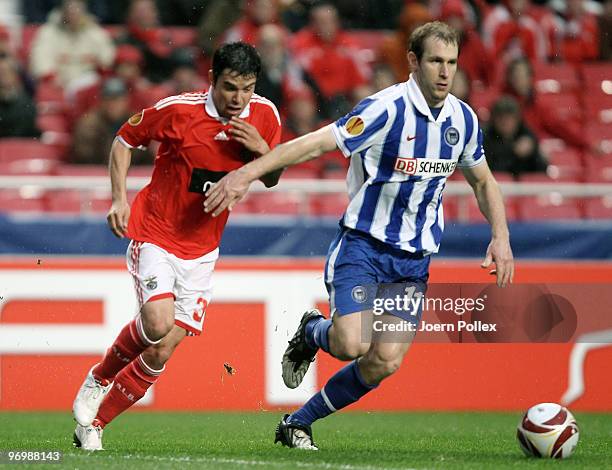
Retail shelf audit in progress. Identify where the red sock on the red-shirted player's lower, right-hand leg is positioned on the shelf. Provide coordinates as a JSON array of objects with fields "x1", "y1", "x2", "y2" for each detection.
[{"x1": 95, "y1": 356, "x2": 165, "y2": 428}]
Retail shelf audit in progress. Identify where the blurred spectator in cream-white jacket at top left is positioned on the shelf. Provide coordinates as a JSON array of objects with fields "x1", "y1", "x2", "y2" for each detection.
[{"x1": 30, "y1": 0, "x2": 115, "y2": 88}]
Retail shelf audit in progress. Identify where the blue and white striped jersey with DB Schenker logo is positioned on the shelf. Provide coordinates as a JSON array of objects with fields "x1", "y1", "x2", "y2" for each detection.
[{"x1": 331, "y1": 77, "x2": 485, "y2": 254}]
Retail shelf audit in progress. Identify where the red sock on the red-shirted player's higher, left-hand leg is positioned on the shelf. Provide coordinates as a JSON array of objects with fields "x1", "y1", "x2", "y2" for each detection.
[{"x1": 92, "y1": 315, "x2": 155, "y2": 385}]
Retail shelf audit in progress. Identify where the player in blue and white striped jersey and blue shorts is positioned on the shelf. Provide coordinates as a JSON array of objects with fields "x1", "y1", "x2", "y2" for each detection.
[{"x1": 204, "y1": 22, "x2": 514, "y2": 449}]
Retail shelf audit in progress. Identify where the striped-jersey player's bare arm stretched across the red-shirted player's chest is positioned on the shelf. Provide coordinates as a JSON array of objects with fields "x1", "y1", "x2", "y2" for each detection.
[{"x1": 204, "y1": 125, "x2": 336, "y2": 217}]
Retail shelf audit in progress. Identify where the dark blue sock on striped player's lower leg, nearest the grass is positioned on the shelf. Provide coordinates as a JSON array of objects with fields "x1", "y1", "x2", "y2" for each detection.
[{"x1": 288, "y1": 361, "x2": 377, "y2": 426}]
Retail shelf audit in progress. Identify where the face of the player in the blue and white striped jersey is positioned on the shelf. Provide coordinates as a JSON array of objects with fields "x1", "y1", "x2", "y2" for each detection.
[{"x1": 408, "y1": 37, "x2": 459, "y2": 107}]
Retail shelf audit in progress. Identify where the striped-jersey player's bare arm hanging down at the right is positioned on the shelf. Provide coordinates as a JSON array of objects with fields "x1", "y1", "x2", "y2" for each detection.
[{"x1": 463, "y1": 162, "x2": 514, "y2": 287}]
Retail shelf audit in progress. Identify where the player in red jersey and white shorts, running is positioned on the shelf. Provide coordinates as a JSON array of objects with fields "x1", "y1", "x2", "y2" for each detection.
[{"x1": 73, "y1": 42, "x2": 281, "y2": 450}]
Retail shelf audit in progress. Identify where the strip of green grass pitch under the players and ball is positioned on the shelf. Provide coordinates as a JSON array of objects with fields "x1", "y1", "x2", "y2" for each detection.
[{"x1": 0, "y1": 412, "x2": 612, "y2": 470}]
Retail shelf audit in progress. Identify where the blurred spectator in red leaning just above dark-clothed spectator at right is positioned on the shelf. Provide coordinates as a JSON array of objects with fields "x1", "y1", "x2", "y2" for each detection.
[{"x1": 504, "y1": 59, "x2": 597, "y2": 150}]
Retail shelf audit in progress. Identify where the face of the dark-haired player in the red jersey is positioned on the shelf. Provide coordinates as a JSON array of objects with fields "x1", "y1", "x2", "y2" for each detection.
[{"x1": 211, "y1": 69, "x2": 257, "y2": 119}]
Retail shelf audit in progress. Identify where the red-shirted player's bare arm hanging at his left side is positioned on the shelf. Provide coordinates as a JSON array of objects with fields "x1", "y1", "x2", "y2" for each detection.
[{"x1": 106, "y1": 138, "x2": 132, "y2": 238}]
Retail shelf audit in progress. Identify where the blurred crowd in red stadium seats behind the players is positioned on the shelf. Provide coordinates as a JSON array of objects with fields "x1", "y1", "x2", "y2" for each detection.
[{"x1": 0, "y1": 0, "x2": 612, "y2": 217}]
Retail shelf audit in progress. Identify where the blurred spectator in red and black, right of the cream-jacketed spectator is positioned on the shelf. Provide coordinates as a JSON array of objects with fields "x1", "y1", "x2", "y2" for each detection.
[{"x1": 116, "y1": 0, "x2": 173, "y2": 83}]
